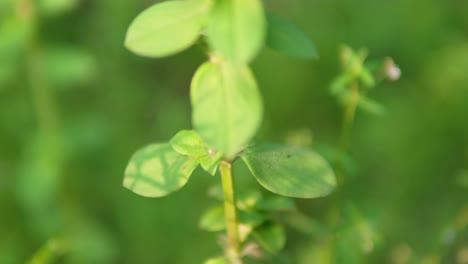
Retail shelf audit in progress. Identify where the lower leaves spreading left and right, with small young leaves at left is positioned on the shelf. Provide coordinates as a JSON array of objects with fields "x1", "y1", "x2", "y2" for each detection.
[{"x1": 124, "y1": 139, "x2": 336, "y2": 198}]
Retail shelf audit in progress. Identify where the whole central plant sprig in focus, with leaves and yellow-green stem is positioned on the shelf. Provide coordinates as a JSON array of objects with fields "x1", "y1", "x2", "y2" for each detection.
[{"x1": 123, "y1": 0, "x2": 336, "y2": 263}]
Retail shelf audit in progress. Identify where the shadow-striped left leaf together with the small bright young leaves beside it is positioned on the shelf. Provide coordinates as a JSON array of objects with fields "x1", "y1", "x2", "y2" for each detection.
[{"x1": 123, "y1": 131, "x2": 221, "y2": 197}]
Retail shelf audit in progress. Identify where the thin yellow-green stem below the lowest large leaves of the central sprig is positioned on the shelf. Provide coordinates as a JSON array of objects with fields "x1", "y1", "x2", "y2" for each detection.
[{"x1": 220, "y1": 161, "x2": 242, "y2": 264}]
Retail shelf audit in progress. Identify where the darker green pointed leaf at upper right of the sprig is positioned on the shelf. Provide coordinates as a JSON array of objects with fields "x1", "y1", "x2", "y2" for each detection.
[{"x1": 266, "y1": 13, "x2": 318, "y2": 59}]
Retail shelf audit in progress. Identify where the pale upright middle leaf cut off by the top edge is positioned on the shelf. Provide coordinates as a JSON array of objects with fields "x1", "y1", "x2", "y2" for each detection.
[{"x1": 207, "y1": 0, "x2": 266, "y2": 63}]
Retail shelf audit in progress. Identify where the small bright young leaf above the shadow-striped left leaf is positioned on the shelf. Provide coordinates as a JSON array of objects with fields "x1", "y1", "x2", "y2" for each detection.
[{"x1": 170, "y1": 130, "x2": 207, "y2": 156}]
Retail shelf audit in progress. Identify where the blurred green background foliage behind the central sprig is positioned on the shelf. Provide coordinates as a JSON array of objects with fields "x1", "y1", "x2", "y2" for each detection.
[{"x1": 0, "y1": 0, "x2": 468, "y2": 264}]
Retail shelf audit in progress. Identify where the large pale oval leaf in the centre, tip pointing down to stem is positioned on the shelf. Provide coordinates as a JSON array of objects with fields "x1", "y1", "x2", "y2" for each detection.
[{"x1": 191, "y1": 62, "x2": 263, "y2": 160}]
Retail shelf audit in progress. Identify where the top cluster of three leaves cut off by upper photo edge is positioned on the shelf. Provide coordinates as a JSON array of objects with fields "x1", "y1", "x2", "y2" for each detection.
[{"x1": 125, "y1": 0, "x2": 317, "y2": 61}]
